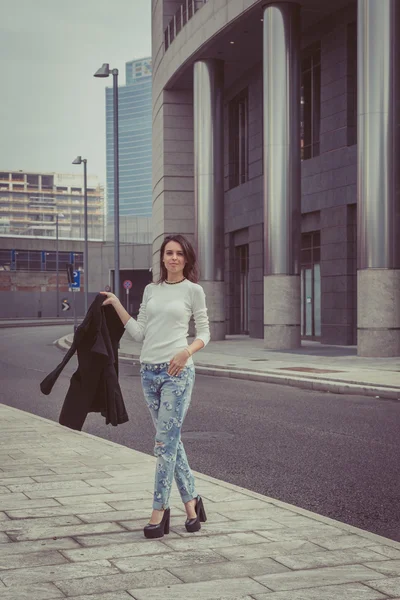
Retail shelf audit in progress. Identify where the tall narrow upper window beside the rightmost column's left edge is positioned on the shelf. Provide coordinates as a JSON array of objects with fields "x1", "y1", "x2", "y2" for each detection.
[{"x1": 347, "y1": 23, "x2": 357, "y2": 146}]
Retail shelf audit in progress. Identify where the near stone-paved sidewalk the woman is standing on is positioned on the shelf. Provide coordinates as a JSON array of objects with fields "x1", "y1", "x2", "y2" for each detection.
[{"x1": 0, "y1": 404, "x2": 400, "y2": 600}]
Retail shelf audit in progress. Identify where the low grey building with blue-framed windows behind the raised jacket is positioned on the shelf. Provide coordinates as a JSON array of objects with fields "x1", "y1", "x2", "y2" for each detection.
[{"x1": 0, "y1": 236, "x2": 151, "y2": 318}]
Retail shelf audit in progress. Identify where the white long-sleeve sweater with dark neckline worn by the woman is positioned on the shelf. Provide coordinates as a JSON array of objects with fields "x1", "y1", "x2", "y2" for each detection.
[{"x1": 125, "y1": 279, "x2": 210, "y2": 365}]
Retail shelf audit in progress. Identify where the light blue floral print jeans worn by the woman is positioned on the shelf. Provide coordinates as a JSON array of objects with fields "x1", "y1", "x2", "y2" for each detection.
[{"x1": 140, "y1": 363, "x2": 197, "y2": 510}]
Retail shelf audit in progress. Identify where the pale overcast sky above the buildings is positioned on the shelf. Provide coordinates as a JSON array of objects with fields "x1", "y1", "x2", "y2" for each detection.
[{"x1": 0, "y1": 0, "x2": 151, "y2": 183}]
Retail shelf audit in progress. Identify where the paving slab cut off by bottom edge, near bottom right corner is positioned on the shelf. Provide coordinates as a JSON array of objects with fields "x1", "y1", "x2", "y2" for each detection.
[{"x1": 254, "y1": 583, "x2": 386, "y2": 600}]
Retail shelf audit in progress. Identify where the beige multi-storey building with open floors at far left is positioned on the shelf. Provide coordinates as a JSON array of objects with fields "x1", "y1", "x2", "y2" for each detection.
[{"x1": 0, "y1": 171, "x2": 104, "y2": 240}]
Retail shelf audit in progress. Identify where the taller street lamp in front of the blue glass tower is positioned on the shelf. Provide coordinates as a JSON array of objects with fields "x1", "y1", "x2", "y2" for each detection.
[{"x1": 94, "y1": 63, "x2": 120, "y2": 297}]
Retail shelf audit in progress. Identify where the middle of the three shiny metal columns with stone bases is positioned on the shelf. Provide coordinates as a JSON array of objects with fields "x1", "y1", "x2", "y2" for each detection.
[{"x1": 263, "y1": 2, "x2": 301, "y2": 350}]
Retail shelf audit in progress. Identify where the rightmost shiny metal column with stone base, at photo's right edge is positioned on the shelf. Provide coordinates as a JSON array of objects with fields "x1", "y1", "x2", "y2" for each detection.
[{"x1": 357, "y1": 0, "x2": 400, "y2": 357}]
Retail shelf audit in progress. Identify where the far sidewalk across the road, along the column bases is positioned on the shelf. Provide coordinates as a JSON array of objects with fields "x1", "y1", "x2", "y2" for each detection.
[{"x1": 58, "y1": 333, "x2": 400, "y2": 400}]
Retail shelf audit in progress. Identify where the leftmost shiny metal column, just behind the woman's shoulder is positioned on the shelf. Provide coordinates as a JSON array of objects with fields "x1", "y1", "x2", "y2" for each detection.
[{"x1": 193, "y1": 59, "x2": 225, "y2": 340}]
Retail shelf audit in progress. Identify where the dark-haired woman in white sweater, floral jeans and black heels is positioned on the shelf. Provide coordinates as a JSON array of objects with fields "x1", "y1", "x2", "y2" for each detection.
[{"x1": 101, "y1": 235, "x2": 210, "y2": 538}]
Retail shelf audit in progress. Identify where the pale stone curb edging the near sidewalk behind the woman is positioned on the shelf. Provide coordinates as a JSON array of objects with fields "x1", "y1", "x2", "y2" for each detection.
[{"x1": 4, "y1": 405, "x2": 400, "y2": 550}]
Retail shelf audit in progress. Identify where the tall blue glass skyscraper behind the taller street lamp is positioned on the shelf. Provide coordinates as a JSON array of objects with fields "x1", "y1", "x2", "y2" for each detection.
[{"x1": 106, "y1": 58, "x2": 152, "y2": 243}]
